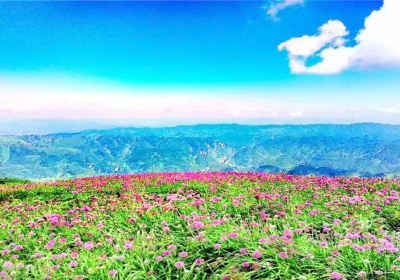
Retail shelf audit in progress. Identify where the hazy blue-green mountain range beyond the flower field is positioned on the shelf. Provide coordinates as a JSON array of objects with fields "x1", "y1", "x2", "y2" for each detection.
[{"x1": 0, "y1": 124, "x2": 400, "y2": 179}]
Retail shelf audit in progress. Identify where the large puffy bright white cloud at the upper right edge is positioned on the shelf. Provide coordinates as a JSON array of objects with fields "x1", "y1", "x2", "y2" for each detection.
[{"x1": 278, "y1": 0, "x2": 400, "y2": 74}]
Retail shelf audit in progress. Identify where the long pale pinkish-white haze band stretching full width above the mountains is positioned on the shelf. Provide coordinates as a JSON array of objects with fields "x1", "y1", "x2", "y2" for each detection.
[{"x1": 0, "y1": 74, "x2": 400, "y2": 123}]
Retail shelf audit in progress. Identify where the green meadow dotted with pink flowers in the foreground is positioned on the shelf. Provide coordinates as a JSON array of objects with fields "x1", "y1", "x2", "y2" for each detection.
[{"x1": 0, "y1": 173, "x2": 400, "y2": 279}]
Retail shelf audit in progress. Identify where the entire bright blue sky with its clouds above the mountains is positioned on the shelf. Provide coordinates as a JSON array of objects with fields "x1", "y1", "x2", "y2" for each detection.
[{"x1": 0, "y1": 0, "x2": 400, "y2": 125}]
